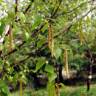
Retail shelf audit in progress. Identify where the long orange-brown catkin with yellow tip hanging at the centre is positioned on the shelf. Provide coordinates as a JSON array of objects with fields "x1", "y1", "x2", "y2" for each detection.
[{"x1": 48, "y1": 23, "x2": 54, "y2": 57}]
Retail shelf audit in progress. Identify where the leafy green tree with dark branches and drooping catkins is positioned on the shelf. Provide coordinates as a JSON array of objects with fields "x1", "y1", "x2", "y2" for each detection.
[{"x1": 0, "y1": 0, "x2": 96, "y2": 96}]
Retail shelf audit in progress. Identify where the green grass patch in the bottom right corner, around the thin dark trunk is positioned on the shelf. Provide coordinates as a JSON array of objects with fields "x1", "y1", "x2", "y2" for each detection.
[{"x1": 60, "y1": 85, "x2": 96, "y2": 96}]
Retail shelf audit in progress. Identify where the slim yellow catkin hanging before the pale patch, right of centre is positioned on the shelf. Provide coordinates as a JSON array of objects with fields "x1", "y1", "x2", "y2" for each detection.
[{"x1": 64, "y1": 49, "x2": 69, "y2": 78}]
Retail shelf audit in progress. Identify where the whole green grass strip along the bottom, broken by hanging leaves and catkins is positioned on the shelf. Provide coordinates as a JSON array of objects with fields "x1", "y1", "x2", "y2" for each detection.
[{"x1": 9, "y1": 85, "x2": 96, "y2": 96}]
